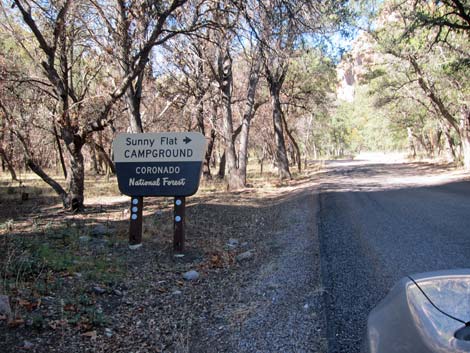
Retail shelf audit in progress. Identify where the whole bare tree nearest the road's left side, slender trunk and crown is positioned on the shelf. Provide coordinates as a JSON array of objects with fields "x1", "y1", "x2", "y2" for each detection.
[{"x1": 240, "y1": 0, "x2": 350, "y2": 179}]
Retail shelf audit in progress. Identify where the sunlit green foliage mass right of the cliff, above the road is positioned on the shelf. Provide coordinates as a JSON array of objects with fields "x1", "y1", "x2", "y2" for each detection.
[{"x1": 331, "y1": 0, "x2": 470, "y2": 158}]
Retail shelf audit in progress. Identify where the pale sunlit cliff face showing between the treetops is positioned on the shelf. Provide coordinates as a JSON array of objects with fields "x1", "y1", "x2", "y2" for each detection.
[{"x1": 336, "y1": 33, "x2": 376, "y2": 102}]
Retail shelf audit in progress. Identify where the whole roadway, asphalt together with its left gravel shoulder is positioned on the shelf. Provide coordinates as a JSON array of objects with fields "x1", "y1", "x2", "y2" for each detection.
[{"x1": 190, "y1": 156, "x2": 470, "y2": 353}]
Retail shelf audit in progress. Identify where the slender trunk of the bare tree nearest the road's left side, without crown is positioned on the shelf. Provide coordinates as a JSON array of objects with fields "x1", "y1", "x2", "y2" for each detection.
[{"x1": 269, "y1": 79, "x2": 292, "y2": 180}]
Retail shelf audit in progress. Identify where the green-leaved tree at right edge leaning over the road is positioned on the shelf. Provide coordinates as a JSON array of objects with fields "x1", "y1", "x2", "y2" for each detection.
[{"x1": 374, "y1": 2, "x2": 470, "y2": 170}]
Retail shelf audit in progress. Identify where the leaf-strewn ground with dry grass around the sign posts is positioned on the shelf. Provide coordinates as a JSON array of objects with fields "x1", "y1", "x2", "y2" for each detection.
[{"x1": 0, "y1": 163, "x2": 326, "y2": 352}]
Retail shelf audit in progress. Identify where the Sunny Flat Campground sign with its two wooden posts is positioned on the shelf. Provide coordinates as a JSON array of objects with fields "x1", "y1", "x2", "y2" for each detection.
[{"x1": 113, "y1": 132, "x2": 206, "y2": 252}]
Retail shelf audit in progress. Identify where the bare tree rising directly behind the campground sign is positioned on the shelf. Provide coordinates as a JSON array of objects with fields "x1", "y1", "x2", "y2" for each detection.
[{"x1": 92, "y1": 0, "x2": 202, "y2": 132}]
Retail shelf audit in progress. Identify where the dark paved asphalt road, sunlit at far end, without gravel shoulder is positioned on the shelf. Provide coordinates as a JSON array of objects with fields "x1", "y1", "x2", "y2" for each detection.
[{"x1": 318, "y1": 161, "x2": 470, "y2": 353}]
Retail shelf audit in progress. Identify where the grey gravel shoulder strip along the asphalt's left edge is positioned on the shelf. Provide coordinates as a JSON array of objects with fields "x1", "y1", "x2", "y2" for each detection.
[{"x1": 232, "y1": 193, "x2": 326, "y2": 352}]
